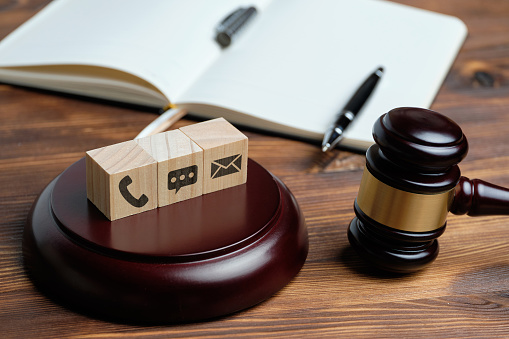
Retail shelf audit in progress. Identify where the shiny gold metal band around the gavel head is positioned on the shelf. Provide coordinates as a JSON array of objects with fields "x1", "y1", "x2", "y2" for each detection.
[{"x1": 357, "y1": 168, "x2": 454, "y2": 232}]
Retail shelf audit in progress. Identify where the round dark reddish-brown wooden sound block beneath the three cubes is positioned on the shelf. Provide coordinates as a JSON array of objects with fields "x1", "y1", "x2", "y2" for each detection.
[{"x1": 23, "y1": 159, "x2": 308, "y2": 323}]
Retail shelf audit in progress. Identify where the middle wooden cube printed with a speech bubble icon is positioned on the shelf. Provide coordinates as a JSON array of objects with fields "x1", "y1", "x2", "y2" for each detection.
[{"x1": 136, "y1": 130, "x2": 203, "y2": 207}]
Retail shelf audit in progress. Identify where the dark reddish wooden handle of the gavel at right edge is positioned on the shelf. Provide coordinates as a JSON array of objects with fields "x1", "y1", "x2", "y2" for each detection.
[{"x1": 450, "y1": 177, "x2": 509, "y2": 216}]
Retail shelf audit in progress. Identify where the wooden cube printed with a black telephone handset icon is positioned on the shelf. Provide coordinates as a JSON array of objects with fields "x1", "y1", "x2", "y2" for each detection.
[{"x1": 86, "y1": 140, "x2": 157, "y2": 220}]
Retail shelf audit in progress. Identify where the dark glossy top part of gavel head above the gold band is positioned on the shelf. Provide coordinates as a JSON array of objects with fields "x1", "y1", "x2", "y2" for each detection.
[{"x1": 366, "y1": 108, "x2": 468, "y2": 194}]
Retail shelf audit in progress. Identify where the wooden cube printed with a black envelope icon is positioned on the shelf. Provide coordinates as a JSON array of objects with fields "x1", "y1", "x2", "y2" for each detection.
[{"x1": 180, "y1": 118, "x2": 247, "y2": 194}]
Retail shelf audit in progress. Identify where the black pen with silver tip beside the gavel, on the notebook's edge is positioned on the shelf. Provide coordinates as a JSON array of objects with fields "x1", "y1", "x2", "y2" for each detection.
[{"x1": 322, "y1": 67, "x2": 384, "y2": 152}]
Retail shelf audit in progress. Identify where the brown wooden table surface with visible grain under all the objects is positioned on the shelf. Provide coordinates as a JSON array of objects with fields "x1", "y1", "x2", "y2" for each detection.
[{"x1": 0, "y1": 0, "x2": 509, "y2": 338}]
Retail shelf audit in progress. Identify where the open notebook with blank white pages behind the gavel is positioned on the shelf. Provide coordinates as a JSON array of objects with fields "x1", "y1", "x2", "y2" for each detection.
[{"x1": 0, "y1": 0, "x2": 466, "y2": 149}]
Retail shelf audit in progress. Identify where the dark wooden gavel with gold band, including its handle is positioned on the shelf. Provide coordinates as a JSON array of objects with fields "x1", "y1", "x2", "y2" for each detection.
[{"x1": 348, "y1": 107, "x2": 509, "y2": 273}]
